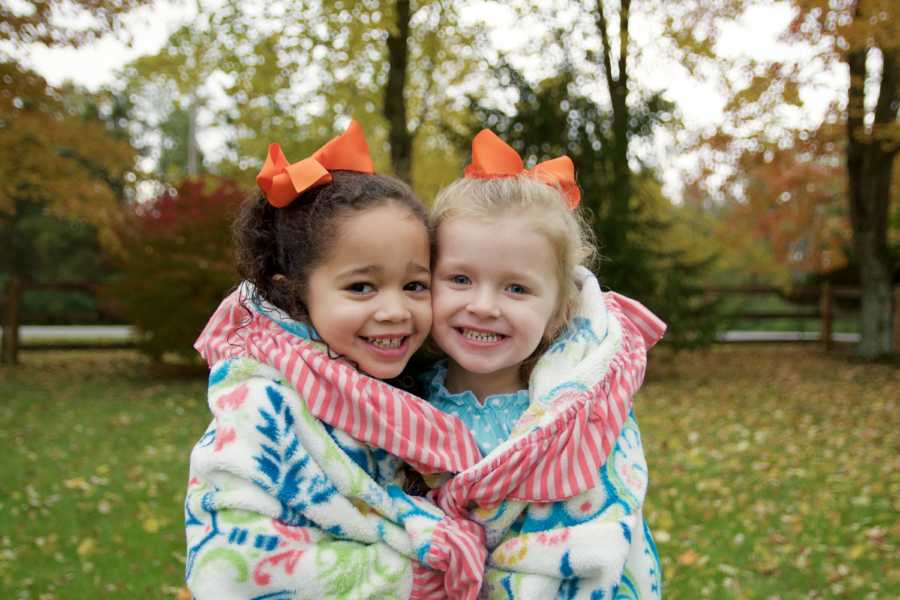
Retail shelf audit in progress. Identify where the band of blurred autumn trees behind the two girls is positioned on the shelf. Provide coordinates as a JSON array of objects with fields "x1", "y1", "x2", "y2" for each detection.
[{"x1": 0, "y1": 0, "x2": 900, "y2": 356}]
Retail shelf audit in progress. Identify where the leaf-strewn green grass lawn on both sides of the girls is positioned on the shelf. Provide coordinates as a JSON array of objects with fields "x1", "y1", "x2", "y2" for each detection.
[{"x1": 0, "y1": 345, "x2": 900, "y2": 599}]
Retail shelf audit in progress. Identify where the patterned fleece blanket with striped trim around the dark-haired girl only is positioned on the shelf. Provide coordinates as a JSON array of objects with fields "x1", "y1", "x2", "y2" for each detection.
[{"x1": 185, "y1": 285, "x2": 486, "y2": 600}]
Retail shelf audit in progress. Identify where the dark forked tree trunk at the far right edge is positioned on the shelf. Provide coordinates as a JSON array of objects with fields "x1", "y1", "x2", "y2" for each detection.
[{"x1": 847, "y1": 49, "x2": 900, "y2": 359}]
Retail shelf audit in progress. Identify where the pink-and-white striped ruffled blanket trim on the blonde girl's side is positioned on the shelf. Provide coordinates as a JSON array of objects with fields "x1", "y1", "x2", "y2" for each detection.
[{"x1": 430, "y1": 292, "x2": 666, "y2": 516}]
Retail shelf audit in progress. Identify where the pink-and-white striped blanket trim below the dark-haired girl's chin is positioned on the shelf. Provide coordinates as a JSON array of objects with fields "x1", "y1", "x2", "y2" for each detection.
[{"x1": 194, "y1": 290, "x2": 481, "y2": 473}]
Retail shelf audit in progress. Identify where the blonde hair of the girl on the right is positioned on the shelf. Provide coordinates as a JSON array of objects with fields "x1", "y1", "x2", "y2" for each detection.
[{"x1": 428, "y1": 175, "x2": 597, "y2": 342}]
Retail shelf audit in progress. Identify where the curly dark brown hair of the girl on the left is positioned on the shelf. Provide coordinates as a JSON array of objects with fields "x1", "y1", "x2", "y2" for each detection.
[{"x1": 234, "y1": 171, "x2": 427, "y2": 322}]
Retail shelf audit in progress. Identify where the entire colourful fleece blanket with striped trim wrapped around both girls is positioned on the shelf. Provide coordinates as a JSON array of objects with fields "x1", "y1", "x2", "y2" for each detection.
[{"x1": 186, "y1": 272, "x2": 664, "y2": 600}]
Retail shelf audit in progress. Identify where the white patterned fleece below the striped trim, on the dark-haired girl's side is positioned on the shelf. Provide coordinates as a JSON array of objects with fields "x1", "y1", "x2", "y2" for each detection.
[{"x1": 185, "y1": 359, "x2": 484, "y2": 600}]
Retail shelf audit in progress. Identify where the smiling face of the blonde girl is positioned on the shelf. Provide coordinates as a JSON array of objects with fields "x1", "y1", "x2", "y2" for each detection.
[{"x1": 432, "y1": 216, "x2": 559, "y2": 391}]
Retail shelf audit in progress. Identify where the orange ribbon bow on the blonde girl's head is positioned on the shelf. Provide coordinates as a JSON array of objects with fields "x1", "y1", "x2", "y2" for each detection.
[{"x1": 463, "y1": 129, "x2": 581, "y2": 210}]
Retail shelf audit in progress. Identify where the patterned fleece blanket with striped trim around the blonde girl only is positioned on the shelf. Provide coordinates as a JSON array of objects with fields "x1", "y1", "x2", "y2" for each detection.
[{"x1": 431, "y1": 270, "x2": 665, "y2": 600}]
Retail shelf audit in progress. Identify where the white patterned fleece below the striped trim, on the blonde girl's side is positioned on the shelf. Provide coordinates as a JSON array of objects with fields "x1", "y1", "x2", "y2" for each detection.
[{"x1": 473, "y1": 413, "x2": 661, "y2": 600}]
